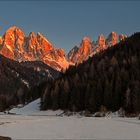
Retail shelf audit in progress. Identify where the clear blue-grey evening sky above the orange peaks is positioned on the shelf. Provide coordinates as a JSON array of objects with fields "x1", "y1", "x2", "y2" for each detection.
[{"x1": 0, "y1": 0, "x2": 140, "y2": 53}]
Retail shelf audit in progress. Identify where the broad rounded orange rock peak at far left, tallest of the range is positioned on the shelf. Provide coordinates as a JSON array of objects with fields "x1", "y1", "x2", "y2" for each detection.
[{"x1": 0, "y1": 26, "x2": 25, "y2": 60}]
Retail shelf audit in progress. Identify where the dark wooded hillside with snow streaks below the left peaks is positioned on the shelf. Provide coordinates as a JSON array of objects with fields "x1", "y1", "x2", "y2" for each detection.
[{"x1": 0, "y1": 55, "x2": 59, "y2": 111}]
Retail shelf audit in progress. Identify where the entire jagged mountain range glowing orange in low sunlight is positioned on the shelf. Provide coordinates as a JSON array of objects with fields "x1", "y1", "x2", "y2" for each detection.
[{"x1": 0, "y1": 26, "x2": 126, "y2": 71}]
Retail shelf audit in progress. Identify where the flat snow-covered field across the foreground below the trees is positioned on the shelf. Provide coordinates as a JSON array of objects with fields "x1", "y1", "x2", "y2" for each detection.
[{"x1": 0, "y1": 115, "x2": 140, "y2": 140}]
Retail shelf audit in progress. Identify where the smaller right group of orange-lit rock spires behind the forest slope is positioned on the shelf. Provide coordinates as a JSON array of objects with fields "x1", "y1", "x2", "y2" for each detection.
[{"x1": 68, "y1": 32, "x2": 126, "y2": 63}]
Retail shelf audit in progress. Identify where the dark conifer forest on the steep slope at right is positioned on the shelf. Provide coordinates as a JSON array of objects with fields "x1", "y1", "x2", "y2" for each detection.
[{"x1": 41, "y1": 33, "x2": 140, "y2": 113}]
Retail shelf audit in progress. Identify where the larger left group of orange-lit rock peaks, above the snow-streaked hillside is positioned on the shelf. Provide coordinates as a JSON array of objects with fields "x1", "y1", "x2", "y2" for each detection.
[{"x1": 0, "y1": 26, "x2": 69, "y2": 71}]
